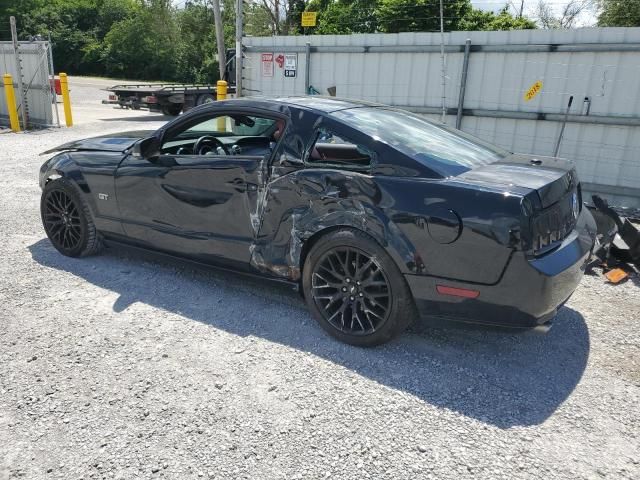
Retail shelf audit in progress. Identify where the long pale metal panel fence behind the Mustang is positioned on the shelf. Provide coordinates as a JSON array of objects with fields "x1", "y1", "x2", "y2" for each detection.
[{"x1": 243, "y1": 28, "x2": 640, "y2": 208}]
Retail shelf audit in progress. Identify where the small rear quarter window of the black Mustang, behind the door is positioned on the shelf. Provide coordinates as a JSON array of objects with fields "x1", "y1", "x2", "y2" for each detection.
[{"x1": 307, "y1": 129, "x2": 373, "y2": 170}]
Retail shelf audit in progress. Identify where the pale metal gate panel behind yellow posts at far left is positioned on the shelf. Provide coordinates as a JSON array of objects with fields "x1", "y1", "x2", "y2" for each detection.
[{"x1": 0, "y1": 41, "x2": 56, "y2": 128}]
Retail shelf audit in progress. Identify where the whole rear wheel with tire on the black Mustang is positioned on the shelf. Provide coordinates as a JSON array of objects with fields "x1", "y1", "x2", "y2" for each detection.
[{"x1": 302, "y1": 229, "x2": 417, "y2": 347}]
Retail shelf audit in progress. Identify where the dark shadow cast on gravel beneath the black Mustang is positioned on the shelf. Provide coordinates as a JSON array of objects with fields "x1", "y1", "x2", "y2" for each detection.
[{"x1": 29, "y1": 239, "x2": 590, "y2": 428}]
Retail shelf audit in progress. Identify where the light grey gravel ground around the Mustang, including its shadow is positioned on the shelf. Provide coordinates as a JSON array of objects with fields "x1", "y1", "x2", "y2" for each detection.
[{"x1": 0, "y1": 79, "x2": 640, "y2": 480}]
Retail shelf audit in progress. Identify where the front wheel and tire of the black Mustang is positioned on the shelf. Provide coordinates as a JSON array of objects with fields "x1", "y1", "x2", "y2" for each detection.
[{"x1": 40, "y1": 178, "x2": 102, "y2": 257}]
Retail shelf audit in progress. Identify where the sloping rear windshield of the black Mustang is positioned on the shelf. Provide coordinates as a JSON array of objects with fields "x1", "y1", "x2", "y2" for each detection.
[{"x1": 332, "y1": 107, "x2": 509, "y2": 177}]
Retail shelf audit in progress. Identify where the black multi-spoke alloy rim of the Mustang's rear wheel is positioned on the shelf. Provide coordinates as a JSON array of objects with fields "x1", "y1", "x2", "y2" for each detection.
[{"x1": 311, "y1": 247, "x2": 391, "y2": 335}]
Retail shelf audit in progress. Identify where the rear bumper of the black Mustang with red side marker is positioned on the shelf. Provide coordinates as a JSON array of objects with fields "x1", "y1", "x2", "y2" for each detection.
[{"x1": 405, "y1": 208, "x2": 596, "y2": 327}]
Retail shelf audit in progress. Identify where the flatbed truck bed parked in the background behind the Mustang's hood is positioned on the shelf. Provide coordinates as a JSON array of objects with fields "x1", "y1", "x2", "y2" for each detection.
[{"x1": 102, "y1": 83, "x2": 235, "y2": 115}]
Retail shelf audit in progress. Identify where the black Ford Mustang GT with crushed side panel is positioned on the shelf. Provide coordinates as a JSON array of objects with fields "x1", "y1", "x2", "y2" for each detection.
[{"x1": 40, "y1": 97, "x2": 596, "y2": 345}]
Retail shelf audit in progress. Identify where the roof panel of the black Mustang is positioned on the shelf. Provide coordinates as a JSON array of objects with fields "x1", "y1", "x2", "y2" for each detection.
[{"x1": 207, "y1": 95, "x2": 387, "y2": 113}]
